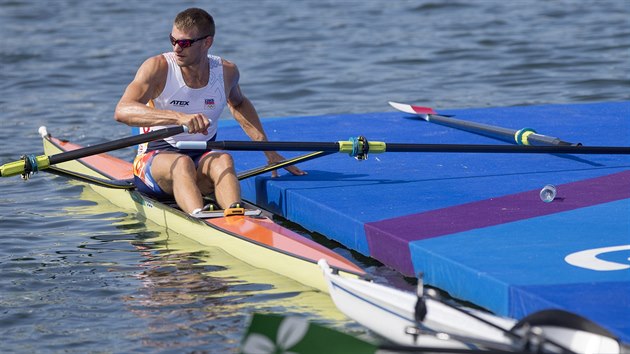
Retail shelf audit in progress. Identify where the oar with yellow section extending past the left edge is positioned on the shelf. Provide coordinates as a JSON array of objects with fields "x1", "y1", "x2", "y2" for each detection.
[{"x1": 0, "y1": 126, "x2": 187, "y2": 178}]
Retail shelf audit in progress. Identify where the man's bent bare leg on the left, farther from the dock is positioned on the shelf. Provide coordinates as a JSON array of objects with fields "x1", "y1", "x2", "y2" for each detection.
[{"x1": 151, "y1": 152, "x2": 203, "y2": 213}]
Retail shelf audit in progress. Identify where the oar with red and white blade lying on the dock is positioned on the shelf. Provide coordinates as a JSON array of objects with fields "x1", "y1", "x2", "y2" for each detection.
[{"x1": 389, "y1": 101, "x2": 582, "y2": 146}]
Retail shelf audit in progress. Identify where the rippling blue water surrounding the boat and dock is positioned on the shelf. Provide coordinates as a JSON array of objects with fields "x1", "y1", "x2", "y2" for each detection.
[{"x1": 0, "y1": 0, "x2": 630, "y2": 353}]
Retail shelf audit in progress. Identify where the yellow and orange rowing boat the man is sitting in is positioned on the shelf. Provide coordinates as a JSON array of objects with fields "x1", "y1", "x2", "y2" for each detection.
[{"x1": 40, "y1": 128, "x2": 364, "y2": 292}]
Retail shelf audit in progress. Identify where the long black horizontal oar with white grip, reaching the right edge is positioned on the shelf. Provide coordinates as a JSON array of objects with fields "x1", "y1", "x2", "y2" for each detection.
[{"x1": 177, "y1": 137, "x2": 630, "y2": 158}]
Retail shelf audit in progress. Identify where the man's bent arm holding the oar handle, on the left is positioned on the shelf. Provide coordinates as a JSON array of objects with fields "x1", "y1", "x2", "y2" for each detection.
[{"x1": 114, "y1": 55, "x2": 210, "y2": 134}]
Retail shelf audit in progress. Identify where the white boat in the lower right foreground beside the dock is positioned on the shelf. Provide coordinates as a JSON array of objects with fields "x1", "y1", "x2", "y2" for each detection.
[{"x1": 319, "y1": 260, "x2": 628, "y2": 353}]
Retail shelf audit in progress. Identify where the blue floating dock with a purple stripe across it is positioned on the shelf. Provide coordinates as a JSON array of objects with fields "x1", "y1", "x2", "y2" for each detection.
[{"x1": 218, "y1": 101, "x2": 630, "y2": 342}]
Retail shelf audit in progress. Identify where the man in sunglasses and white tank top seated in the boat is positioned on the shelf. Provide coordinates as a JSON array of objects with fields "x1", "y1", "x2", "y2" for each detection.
[{"x1": 114, "y1": 8, "x2": 305, "y2": 214}]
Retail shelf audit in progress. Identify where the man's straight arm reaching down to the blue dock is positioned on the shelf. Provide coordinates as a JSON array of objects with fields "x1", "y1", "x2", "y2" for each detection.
[{"x1": 223, "y1": 60, "x2": 306, "y2": 177}]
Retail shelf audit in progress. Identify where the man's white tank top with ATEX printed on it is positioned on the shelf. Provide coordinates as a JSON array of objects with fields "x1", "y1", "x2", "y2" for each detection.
[{"x1": 138, "y1": 52, "x2": 227, "y2": 154}]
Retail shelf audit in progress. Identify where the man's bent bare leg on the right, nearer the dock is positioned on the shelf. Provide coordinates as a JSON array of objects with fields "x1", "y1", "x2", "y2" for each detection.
[{"x1": 197, "y1": 152, "x2": 241, "y2": 209}]
